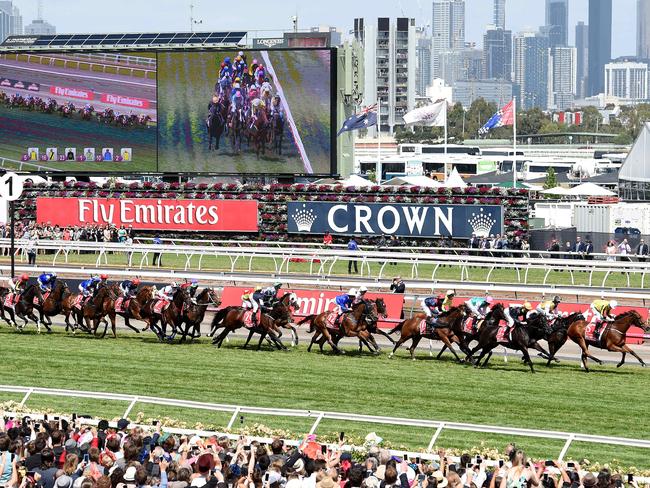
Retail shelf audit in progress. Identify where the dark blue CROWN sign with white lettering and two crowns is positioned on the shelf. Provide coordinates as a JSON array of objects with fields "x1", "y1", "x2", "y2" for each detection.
[{"x1": 287, "y1": 202, "x2": 503, "y2": 238}]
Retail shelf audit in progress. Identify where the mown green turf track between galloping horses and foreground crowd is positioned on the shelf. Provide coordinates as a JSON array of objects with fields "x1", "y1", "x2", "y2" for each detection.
[{"x1": 0, "y1": 326, "x2": 650, "y2": 468}]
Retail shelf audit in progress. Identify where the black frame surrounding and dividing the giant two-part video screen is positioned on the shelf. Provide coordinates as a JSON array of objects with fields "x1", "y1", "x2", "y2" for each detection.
[{"x1": 0, "y1": 46, "x2": 339, "y2": 178}]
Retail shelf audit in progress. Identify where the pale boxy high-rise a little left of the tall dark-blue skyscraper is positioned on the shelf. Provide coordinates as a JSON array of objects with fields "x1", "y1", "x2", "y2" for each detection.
[{"x1": 548, "y1": 47, "x2": 578, "y2": 110}]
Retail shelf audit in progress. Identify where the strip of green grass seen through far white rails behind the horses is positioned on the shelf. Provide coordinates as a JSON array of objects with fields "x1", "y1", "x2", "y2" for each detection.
[{"x1": 8, "y1": 249, "x2": 650, "y2": 288}]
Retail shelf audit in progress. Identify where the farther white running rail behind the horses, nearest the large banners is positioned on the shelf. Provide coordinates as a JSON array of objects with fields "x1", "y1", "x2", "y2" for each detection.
[{"x1": 5, "y1": 239, "x2": 650, "y2": 288}]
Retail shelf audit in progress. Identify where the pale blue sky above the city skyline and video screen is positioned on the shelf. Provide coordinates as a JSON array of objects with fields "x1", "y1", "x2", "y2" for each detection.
[{"x1": 14, "y1": 0, "x2": 636, "y2": 56}]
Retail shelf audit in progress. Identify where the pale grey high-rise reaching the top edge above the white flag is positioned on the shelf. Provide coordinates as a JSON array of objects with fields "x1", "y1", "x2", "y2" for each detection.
[{"x1": 431, "y1": 0, "x2": 465, "y2": 78}]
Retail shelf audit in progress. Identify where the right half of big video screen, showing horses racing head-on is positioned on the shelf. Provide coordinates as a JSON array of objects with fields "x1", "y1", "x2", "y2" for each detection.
[{"x1": 158, "y1": 49, "x2": 332, "y2": 174}]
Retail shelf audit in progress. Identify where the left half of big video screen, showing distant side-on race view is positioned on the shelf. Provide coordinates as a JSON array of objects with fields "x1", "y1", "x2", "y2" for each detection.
[{"x1": 0, "y1": 52, "x2": 158, "y2": 172}]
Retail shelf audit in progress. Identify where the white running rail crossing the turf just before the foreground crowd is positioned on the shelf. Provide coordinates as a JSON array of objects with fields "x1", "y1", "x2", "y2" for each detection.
[{"x1": 0, "y1": 385, "x2": 650, "y2": 460}]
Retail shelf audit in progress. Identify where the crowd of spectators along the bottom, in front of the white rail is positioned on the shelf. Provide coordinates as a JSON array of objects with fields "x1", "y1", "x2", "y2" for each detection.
[{"x1": 0, "y1": 417, "x2": 638, "y2": 488}]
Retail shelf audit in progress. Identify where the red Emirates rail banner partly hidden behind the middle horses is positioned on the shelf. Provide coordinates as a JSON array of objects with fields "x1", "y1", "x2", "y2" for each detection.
[{"x1": 221, "y1": 286, "x2": 404, "y2": 328}]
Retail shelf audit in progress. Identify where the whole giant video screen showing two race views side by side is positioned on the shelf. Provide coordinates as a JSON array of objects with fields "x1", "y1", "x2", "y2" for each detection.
[{"x1": 0, "y1": 49, "x2": 336, "y2": 174}]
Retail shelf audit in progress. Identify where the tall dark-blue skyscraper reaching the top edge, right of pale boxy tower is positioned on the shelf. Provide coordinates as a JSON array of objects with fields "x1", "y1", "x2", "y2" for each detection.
[{"x1": 587, "y1": 0, "x2": 612, "y2": 96}]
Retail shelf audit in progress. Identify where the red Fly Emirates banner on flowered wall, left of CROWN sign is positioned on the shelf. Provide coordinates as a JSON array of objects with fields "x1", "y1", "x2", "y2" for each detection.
[{"x1": 36, "y1": 198, "x2": 257, "y2": 232}]
